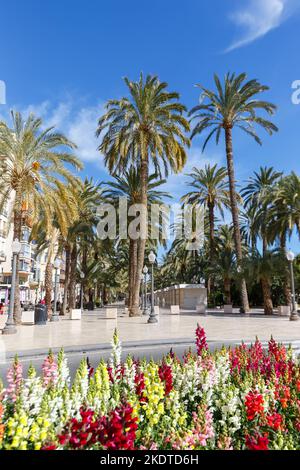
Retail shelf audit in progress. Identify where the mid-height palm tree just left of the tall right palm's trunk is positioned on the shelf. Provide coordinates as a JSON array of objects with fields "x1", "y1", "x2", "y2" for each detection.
[{"x1": 181, "y1": 165, "x2": 230, "y2": 300}]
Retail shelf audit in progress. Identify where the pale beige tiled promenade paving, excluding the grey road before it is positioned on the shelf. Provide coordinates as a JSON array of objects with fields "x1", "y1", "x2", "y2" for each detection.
[{"x1": 0, "y1": 310, "x2": 300, "y2": 360}]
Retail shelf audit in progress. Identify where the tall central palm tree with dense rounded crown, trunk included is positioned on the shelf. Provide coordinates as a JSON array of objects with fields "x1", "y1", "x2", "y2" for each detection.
[{"x1": 97, "y1": 74, "x2": 189, "y2": 316}]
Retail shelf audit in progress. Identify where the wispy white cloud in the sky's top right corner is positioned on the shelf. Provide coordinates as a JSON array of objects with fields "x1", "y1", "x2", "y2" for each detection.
[{"x1": 226, "y1": 0, "x2": 299, "y2": 52}]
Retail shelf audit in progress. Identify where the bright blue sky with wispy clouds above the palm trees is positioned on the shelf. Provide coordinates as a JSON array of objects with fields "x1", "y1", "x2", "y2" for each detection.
[{"x1": 0, "y1": 0, "x2": 300, "y2": 250}]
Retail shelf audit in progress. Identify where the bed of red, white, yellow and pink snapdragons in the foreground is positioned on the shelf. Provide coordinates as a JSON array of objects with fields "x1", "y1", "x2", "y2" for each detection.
[{"x1": 0, "y1": 326, "x2": 300, "y2": 450}]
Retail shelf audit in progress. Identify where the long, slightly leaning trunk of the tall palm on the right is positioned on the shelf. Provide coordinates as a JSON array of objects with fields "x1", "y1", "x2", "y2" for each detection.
[{"x1": 225, "y1": 126, "x2": 250, "y2": 313}]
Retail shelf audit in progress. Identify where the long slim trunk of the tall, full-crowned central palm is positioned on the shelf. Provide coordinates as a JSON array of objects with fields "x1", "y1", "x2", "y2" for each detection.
[{"x1": 129, "y1": 158, "x2": 149, "y2": 317}]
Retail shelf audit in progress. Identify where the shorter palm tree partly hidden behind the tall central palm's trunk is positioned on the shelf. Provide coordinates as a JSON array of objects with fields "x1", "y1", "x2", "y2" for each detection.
[{"x1": 103, "y1": 166, "x2": 170, "y2": 309}]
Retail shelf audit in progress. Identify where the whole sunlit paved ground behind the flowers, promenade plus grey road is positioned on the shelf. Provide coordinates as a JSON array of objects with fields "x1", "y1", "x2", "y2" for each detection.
[{"x1": 0, "y1": 308, "x2": 300, "y2": 382}]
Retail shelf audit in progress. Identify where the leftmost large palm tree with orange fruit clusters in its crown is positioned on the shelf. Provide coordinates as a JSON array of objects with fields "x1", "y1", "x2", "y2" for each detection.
[{"x1": 0, "y1": 111, "x2": 82, "y2": 323}]
